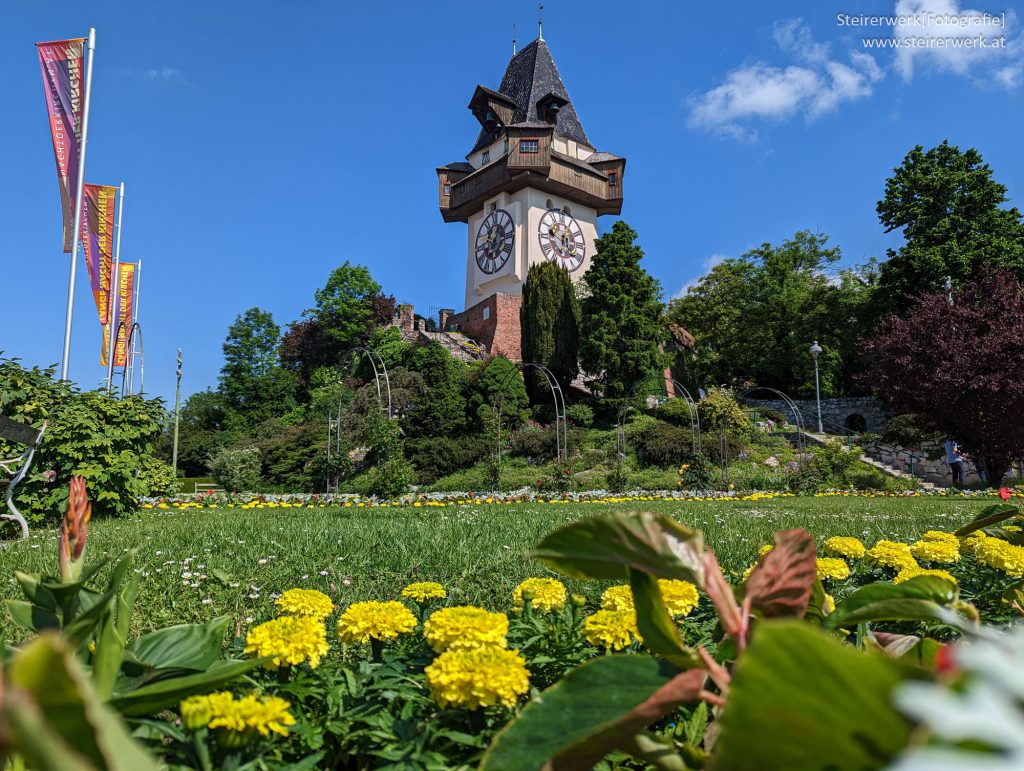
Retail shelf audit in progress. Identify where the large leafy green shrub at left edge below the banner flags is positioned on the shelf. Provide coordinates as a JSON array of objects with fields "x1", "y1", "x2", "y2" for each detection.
[{"x1": 0, "y1": 359, "x2": 166, "y2": 522}]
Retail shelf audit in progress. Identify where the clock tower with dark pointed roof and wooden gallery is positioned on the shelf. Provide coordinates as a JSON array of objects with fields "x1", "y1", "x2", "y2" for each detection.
[{"x1": 437, "y1": 37, "x2": 626, "y2": 358}]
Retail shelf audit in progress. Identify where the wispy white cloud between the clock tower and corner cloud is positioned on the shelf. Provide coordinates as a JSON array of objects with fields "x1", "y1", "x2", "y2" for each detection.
[{"x1": 689, "y1": 18, "x2": 883, "y2": 140}]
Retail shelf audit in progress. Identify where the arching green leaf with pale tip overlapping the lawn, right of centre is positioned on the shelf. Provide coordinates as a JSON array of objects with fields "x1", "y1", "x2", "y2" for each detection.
[{"x1": 531, "y1": 511, "x2": 703, "y2": 586}]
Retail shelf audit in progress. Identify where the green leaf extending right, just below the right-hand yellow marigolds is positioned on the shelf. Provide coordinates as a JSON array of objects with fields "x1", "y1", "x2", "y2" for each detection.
[{"x1": 825, "y1": 575, "x2": 956, "y2": 629}]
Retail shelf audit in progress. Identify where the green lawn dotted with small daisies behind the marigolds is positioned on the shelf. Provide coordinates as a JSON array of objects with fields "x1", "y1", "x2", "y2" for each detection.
[{"x1": 0, "y1": 498, "x2": 991, "y2": 643}]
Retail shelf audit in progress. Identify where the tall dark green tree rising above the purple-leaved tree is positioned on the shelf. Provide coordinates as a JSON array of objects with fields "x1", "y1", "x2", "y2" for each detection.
[{"x1": 877, "y1": 141, "x2": 1024, "y2": 313}]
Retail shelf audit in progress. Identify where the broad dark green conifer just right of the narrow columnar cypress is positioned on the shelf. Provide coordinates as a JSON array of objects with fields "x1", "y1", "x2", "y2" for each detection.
[{"x1": 580, "y1": 220, "x2": 666, "y2": 399}]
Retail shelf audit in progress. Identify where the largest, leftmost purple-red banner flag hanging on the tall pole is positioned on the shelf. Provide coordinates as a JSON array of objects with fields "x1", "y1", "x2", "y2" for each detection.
[{"x1": 36, "y1": 38, "x2": 85, "y2": 253}]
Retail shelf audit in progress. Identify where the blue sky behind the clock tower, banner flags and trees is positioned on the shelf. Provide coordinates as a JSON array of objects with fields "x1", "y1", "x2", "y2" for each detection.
[{"x1": 0, "y1": 0, "x2": 1024, "y2": 399}]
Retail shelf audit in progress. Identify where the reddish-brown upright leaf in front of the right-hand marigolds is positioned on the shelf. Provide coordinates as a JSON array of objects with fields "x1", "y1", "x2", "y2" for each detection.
[{"x1": 746, "y1": 528, "x2": 817, "y2": 618}]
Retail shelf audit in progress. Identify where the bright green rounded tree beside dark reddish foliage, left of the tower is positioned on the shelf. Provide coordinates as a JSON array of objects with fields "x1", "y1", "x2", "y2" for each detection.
[{"x1": 307, "y1": 260, "x2": 381, "y2": 348}]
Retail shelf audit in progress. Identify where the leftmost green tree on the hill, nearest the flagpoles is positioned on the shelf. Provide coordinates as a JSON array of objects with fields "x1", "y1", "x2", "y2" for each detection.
[{"x1": 220, "y1": 308, "x2": 295, "y2": 427}]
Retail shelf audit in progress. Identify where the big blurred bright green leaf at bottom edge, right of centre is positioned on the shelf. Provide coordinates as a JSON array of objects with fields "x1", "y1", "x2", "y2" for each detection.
[{"x1": 710, "y1": 620, "x2": 910, "y2": 771}]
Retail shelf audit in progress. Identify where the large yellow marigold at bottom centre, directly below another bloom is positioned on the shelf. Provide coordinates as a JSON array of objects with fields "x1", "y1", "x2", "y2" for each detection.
[{"x1": 424, "y1": 646, "x2": 529, "y2": 710}]
